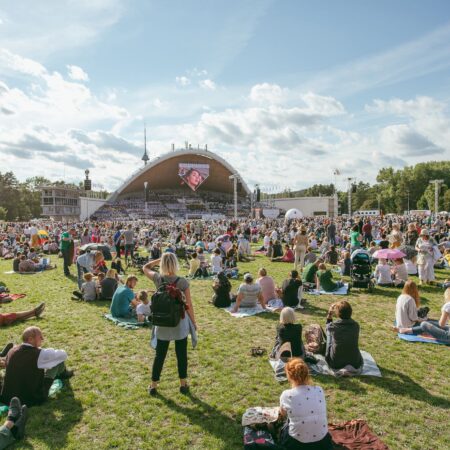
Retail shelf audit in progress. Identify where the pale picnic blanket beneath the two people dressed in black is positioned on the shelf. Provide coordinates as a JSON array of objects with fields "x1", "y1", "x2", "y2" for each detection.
[{"x1": 269, "y1": 350, "x2": 382, "y2": 382}]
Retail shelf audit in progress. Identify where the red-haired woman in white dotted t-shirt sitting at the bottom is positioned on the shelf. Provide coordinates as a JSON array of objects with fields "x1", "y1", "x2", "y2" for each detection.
[{"x1": 280, "y1": 358, "x2": 333, "y2": 450}]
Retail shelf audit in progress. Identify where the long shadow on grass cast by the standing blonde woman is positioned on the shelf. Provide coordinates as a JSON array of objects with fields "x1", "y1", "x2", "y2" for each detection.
[{"x1": 158, "y1": 394, "x2": 242, "y2": 448}]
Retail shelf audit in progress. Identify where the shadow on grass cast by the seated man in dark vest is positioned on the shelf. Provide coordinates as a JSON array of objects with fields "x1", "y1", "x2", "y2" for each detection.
[{"x1": 21, "y1": 382, "x2": 83, "y2": 448}]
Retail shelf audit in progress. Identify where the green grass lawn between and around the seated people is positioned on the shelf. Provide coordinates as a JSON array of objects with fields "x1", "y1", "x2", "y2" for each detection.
[{"x1": 0, "y1": 251, "x2": 450, "y2": 450}]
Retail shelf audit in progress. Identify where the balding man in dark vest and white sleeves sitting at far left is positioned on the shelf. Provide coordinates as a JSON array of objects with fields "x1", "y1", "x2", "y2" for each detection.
[{"x1": 0, "y1": 327, "x2": 74, "y2": 406}]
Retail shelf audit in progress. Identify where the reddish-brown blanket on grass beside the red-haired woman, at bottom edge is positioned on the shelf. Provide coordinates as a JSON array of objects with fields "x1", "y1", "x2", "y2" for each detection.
[{"x1": 328, "y1": 419, "x2": 389, "y2": 450}]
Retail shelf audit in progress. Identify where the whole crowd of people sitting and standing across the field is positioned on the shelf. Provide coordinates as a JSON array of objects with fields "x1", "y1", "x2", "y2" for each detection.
[{"x1": 0, "y1": 216, "x2": 450, "y2": 449}]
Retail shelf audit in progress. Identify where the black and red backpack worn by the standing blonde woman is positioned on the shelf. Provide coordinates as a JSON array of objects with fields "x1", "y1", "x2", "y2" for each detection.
[{"x1": 149, "y1": 278, "x2": 186, "y2": 327}]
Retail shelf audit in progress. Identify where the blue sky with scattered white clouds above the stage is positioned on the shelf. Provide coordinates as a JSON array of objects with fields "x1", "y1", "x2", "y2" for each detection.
[{"x1": 0, "y1": 0, "x2": 450, "y2": 191}]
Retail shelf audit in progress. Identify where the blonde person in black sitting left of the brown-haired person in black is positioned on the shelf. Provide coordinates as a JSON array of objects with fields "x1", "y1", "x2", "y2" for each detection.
[{"x1": 270, "y1": 307, "x2": 305, "y2": 358}]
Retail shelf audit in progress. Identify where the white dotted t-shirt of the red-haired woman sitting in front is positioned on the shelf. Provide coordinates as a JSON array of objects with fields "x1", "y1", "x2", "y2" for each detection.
[{"x1": 280, "y1": 386, "x2": 328, "y2": 443}]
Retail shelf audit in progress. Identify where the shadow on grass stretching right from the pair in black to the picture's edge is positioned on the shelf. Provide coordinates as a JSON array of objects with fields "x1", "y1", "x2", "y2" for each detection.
[{"x1": 360, "y1": 367, "x2": 450, "y2": 409}]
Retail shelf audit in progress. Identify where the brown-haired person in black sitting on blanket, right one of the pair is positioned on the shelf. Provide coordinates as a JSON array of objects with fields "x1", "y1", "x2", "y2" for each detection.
[{"x1": 325, "y1": 300, "x2": 363, "y2": 370}]
